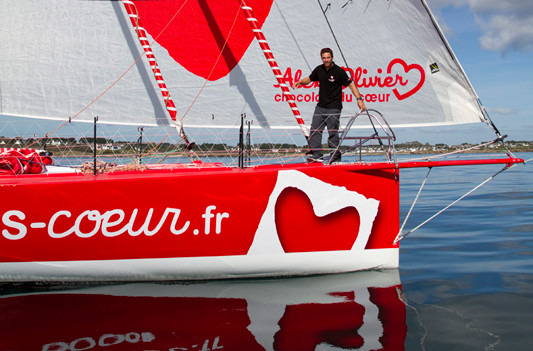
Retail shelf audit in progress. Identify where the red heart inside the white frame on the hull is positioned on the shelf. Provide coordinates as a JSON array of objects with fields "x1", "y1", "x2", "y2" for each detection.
[{"x1": 274, "y1": 187, "x2": 360, "y2": 252}]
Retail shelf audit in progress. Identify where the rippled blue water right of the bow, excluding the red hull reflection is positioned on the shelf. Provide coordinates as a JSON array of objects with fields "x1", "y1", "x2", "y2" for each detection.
[{"x1": 400, "y1": 153, "x2": 533, "y2": 350}]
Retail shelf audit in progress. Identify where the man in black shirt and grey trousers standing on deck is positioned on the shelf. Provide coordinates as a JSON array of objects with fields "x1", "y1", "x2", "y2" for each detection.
[{"x1": 292, "y1": 48, "x2": 366, "y2": 162}]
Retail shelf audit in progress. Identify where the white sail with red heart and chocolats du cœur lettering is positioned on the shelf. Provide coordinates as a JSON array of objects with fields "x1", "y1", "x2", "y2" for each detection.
[{"x1": 0, "y1": 0, "x2": 482, "y2": 128}]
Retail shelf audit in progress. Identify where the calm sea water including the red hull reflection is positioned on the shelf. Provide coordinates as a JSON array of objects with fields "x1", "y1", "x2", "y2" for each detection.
[{"x1": 0, "y1": 153, "x2": 533, "y2": 351}]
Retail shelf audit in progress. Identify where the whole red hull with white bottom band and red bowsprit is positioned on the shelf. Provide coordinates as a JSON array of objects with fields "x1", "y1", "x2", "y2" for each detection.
[{"x1": 0, "y1": 158, "x2": 521, "y2": 281}]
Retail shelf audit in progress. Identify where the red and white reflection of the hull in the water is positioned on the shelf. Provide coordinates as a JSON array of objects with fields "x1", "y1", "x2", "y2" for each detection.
[{"x1": 0, "y1": 270, "x2": 407, "y2": 351}]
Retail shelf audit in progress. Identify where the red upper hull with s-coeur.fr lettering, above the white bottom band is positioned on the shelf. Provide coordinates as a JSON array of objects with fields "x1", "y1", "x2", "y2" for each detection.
[{"x1": 0, "y1": 164, "x2": 399, "y2": 280}]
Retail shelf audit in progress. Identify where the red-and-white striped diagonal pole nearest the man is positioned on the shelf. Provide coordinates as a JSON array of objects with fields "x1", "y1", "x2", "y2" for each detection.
[{"x1": 240, "y1": 0, "x2": 309, "y2": 140}]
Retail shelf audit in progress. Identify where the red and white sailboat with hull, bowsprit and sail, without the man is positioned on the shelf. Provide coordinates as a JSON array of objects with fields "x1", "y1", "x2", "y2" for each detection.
[{"x1": 0, "y1": 0, "x2": 523, "y2": 281}]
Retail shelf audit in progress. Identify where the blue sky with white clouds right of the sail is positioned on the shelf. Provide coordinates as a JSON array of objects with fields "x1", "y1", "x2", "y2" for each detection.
[{"x1": 400, "y1": 0, "x2": 533, "y2": 143}]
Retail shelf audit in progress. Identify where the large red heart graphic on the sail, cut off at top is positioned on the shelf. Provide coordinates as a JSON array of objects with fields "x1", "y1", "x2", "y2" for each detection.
[{"x1": 134, "y1": 0, "x2": 273, "y2": 81}]
